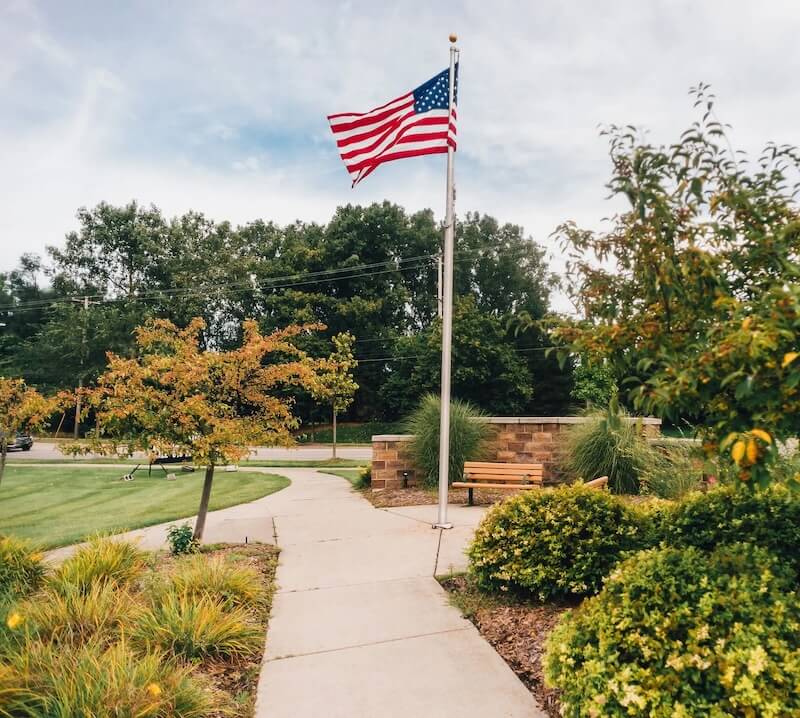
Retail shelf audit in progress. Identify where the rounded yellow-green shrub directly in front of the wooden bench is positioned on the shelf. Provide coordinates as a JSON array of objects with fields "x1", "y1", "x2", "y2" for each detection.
[{"x1": 468, "y1": 486, "x2": 647, "y2": 600}]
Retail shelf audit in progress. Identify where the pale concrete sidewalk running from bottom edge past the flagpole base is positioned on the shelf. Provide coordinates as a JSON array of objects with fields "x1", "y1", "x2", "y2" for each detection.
[{"x1": 256, "y1": 469, "x2": 545, "y2": 718}]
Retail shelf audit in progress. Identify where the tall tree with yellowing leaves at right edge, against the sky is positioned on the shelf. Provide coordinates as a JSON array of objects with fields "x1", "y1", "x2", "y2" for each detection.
[{"x1": 557, "y1": 86, "x2": 800, "y2": 486}]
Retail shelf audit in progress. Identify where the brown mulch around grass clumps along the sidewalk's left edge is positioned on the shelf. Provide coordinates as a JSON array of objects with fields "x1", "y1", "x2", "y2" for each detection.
[{"x1": 154, "y1": 543, "x2": 280, "y2": 718}]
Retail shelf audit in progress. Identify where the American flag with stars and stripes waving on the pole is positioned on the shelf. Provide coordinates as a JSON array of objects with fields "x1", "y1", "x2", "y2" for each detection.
[{"x1": 328, "y1": 64, "x2": 458, "y2": 187}]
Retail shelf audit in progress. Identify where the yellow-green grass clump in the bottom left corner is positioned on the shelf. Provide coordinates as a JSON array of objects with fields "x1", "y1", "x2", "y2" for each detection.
[{"x1": 0, "y1": 643, "x2": 220, "y2": 718}]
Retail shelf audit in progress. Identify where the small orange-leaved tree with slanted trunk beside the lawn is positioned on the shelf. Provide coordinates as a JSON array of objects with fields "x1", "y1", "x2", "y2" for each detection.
[{"x1": 65, "y1": 318, "x2": 319, "y2": 540}]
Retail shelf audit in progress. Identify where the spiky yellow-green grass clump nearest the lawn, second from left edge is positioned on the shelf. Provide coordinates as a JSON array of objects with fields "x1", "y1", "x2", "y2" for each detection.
[{"x1": 50, "y1": 537, "x2": 147, "y2": 593}]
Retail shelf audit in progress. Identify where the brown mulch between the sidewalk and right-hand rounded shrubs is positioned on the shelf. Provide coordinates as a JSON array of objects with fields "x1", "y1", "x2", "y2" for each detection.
[{"x1": 440, "y1": 575, "x2": 574, "y2": 718}]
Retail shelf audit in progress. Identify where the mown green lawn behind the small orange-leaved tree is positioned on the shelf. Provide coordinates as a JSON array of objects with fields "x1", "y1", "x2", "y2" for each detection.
[{"x1": 0, "y1": 463, "x2": 289, "y2": 548}]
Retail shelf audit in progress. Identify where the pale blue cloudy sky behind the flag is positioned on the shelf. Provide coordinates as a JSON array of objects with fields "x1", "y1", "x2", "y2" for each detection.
[{"x1": 0, "y1": 0, "x2": 800, "y2": 310}]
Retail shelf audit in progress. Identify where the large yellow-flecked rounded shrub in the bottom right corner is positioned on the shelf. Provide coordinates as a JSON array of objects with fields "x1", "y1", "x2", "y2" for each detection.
[{"x1": 544, "y1": 544, "x2": 800, "y2": 718}]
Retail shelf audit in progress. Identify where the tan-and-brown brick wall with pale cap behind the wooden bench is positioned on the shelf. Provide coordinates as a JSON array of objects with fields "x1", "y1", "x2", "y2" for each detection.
[{"x1": 372, "y1": 416, "x2": 661, "y2": 489}]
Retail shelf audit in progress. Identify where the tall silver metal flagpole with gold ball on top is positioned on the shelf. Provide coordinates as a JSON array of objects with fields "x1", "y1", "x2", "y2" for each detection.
[{"x1": 433, "y1": 35, "x2": 459, "y2": 529}]
